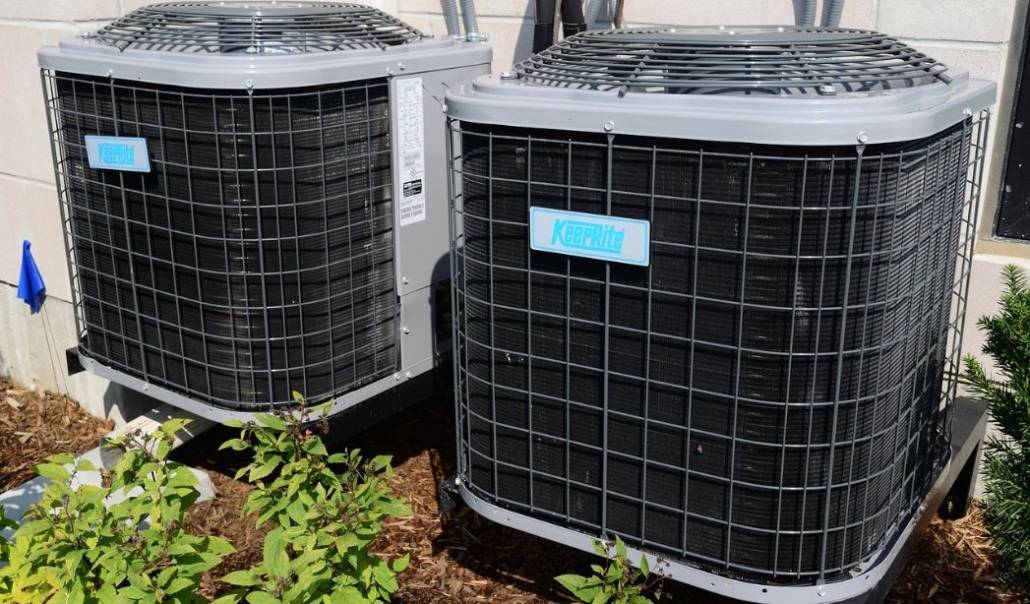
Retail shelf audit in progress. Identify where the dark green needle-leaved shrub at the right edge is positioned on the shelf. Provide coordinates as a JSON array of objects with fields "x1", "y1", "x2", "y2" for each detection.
[{"x1": 965, "y1": 265, "x2": 1030, "y2": 590}]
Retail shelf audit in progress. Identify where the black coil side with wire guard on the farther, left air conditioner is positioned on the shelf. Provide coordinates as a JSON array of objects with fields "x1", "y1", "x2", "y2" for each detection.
[{"x1": 43, "y1": 71, "x2": 399, "y2": 411}]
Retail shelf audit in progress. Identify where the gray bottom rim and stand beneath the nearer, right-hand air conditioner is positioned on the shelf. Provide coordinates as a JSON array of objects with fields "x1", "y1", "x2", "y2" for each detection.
[{"x1": 456, "y1": 397, "x2": 987, "y2": 604}]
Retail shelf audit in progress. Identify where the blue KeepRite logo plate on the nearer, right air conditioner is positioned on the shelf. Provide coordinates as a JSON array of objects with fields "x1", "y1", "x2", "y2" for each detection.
[{"x1": 529, "y1": 207, "x2": 651, "y2": 266}]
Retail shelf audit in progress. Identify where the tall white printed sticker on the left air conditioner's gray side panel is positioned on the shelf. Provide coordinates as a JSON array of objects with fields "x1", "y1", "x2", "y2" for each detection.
[{"x1": 397, "y1": 77, "x2": 425, "y2": 227}]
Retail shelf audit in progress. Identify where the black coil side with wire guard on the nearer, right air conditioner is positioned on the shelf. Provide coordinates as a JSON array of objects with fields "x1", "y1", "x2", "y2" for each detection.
[{"x1": 452, "y1": 112, "x2": 988, "y2": 584}]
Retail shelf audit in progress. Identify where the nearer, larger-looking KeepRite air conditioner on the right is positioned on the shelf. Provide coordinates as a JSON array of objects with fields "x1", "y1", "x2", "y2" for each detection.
[{"x1": 447, "y1": 27, "x2": 995, "y2": 602}]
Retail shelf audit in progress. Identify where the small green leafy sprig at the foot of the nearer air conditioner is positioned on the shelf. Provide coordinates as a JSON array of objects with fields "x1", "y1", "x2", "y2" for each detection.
[{"x1": 554, "y1": 536, "x2": 662, "y2": 604}]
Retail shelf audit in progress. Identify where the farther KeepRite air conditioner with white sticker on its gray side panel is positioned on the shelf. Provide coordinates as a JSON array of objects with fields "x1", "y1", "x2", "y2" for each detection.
[{"x1": 39, "y1": 1, "x2": 491, "y2": 418}]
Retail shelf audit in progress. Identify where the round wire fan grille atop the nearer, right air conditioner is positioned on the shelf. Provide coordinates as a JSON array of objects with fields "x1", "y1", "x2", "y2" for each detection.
[{"x1": 515, "y1": 27, "x2": 950, "y2": 95}]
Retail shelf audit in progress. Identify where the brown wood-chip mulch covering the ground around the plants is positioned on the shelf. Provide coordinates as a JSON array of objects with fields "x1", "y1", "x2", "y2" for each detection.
[{"x1": 0, "y1": 380, "x2": 1028, "y2": 604}]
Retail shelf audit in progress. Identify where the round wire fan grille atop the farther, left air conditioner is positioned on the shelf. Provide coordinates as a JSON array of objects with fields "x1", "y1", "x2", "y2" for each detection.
[{"x1": 96, "y1": 2, "x2": 422, "y2": 55}]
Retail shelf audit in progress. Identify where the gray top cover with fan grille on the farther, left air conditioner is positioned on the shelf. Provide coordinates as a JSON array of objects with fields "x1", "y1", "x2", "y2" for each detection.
[{"x1": 39, "y1": 0, "x2": 489, "y2": 90}]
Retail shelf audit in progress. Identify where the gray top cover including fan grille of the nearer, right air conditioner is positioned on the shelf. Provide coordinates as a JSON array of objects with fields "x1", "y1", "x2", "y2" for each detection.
[{"x1": 447, "y1": 26, "x2": 996, "y2": 145}]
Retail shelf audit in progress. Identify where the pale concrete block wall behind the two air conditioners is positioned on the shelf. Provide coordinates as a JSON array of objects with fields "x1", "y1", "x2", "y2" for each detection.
[{"x1": 0, "y1": 0, "x2": 1030, "y2": 418}]
